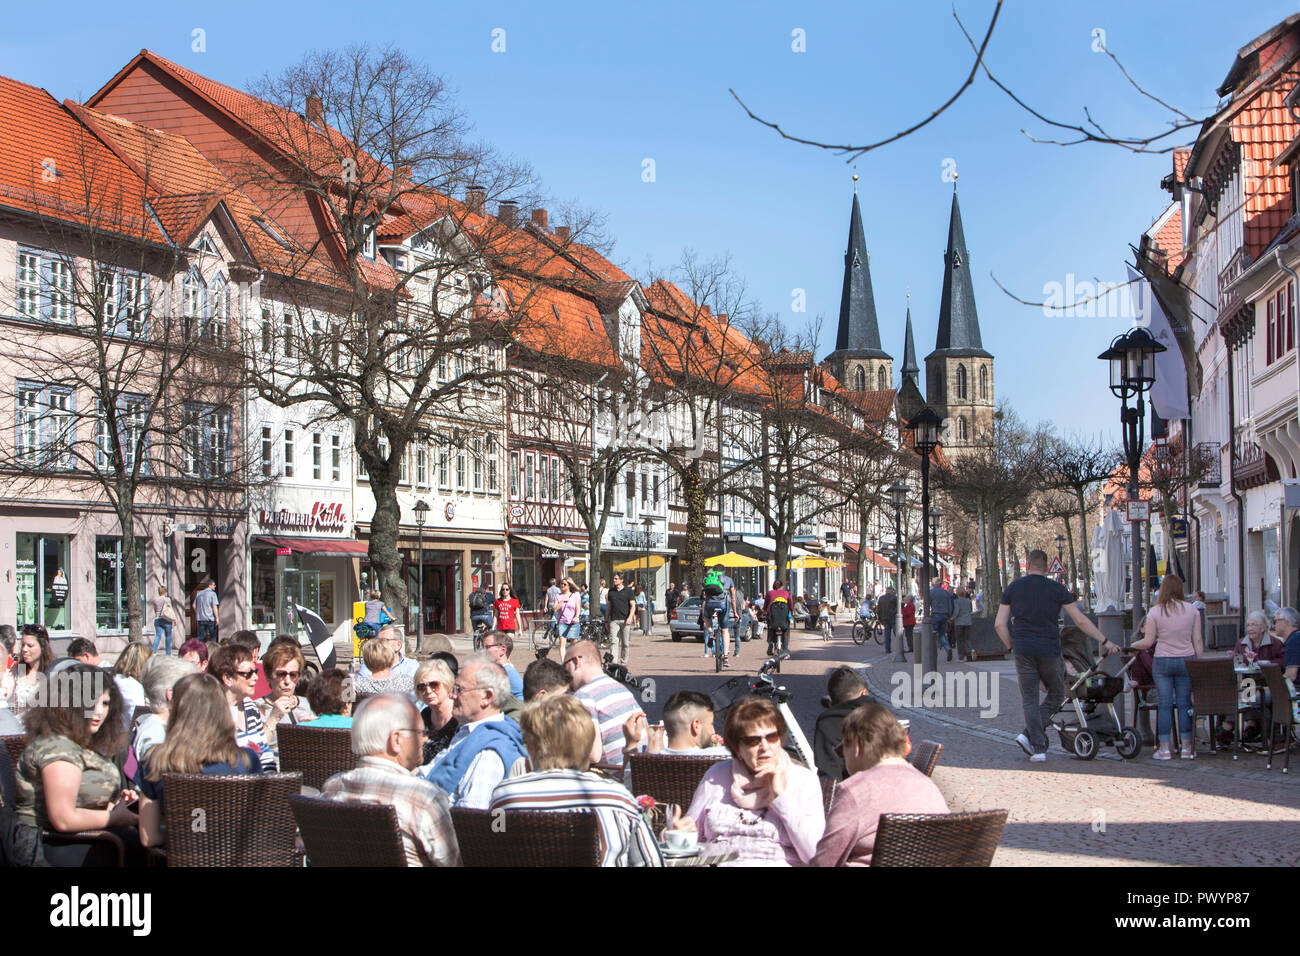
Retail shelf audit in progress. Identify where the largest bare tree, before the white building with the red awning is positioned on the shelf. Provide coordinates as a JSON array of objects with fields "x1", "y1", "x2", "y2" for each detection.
[{"x1": 225, "y1": 47, "x2": 594, "y2": 606}]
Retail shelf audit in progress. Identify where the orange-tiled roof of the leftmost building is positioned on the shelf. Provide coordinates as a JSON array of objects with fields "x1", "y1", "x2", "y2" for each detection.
[{"x1": 0, "y1": 77, "x2": 168, "y2": 243}]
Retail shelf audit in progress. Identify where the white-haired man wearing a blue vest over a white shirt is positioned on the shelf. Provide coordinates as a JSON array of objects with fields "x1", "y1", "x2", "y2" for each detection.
[{"x1": 423, "y1": 653, "x2": 527, "y2": 810}]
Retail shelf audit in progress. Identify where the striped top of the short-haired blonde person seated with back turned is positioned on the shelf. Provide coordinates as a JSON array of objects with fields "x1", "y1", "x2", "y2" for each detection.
[{"x1": 490, "y1": 770, "x2": 663, "y2": 866}]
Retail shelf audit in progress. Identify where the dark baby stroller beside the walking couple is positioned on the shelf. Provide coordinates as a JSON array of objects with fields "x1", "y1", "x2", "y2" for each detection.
[{"x1": 1048, "y1": 627, "x2": 1141, "y2": 760}]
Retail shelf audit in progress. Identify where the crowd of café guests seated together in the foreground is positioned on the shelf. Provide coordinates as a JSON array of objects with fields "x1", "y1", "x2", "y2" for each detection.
[{"x1": 0, "y1": 613, "x2": 943, "y2": 866}]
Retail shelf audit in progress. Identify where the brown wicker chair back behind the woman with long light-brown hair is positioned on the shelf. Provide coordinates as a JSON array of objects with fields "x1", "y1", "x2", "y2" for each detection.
[{"x1": 163, "y1": 774, "x2": 303, "y2": 866}]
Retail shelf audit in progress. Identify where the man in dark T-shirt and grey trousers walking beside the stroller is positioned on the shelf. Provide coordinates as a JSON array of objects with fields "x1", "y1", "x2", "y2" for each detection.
[{"x1": 993, "y1": 548, "x2": 1119, "y2": 762}]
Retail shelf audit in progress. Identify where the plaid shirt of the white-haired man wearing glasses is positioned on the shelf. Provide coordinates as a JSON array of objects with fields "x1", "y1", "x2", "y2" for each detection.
[{"x1": 321, "y1": 757, "x2": 460, "y2": 866}]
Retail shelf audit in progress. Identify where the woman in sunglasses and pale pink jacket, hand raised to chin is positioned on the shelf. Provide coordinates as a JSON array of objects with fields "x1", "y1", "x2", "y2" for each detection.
[{"x1": 670, "y1": 697, "x2": 826, "y2": 866}]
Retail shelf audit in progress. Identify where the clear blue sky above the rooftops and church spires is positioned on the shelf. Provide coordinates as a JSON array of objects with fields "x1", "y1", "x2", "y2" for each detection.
[{"x1": 0, "y1": 0, "x2": 1295, "y2": 438}]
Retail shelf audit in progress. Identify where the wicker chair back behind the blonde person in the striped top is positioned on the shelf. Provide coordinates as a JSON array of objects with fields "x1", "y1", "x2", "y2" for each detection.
[{"x1": 451, "y1": 806, "x2": 601, "y2": 866}]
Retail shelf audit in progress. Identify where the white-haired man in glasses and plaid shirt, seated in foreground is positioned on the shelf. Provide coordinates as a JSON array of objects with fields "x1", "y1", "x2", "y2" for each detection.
[{"x1": 321, "y1": 693, "x2": 460, "y2": 866}]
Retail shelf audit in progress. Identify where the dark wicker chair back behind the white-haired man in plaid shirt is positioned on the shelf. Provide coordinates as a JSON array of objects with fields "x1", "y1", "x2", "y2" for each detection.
[{"x1": 289, "y1": 796, "x2": 407, "y2": 866}]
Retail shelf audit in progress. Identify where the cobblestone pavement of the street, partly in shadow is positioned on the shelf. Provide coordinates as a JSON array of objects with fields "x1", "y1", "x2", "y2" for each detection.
[{"x1": 488, "y1": 624, "x2": 1300, "y2": 866}]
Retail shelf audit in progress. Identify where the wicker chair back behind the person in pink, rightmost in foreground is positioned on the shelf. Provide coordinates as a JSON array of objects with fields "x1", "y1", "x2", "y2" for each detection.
[{"x1": 871, "y1": 810, "x2": 1006, "y2": 866}]
